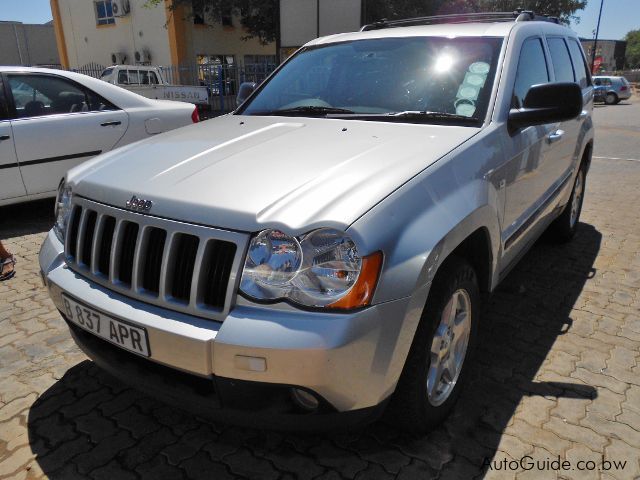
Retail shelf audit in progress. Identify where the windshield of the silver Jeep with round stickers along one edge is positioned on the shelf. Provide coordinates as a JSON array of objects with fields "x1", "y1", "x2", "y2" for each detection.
[{"x1": 238, "y1": 37, "x2": 502, "y2": 121}]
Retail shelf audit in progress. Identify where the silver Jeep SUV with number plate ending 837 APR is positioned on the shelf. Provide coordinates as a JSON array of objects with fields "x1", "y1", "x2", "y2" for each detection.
[{"x1": 40, "y1": 12, "x2": 593, "y2": 431}]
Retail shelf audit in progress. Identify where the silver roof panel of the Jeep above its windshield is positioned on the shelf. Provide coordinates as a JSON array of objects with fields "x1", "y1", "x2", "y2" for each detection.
[{"x1": 306, "y1": 21, "x2": 577, "y2": 46}]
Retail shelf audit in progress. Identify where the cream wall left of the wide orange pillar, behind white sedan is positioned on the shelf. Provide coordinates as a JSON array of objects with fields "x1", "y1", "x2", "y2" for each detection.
[{"x1": 57, "y1": 0, "x2": 171, "y2": 68}]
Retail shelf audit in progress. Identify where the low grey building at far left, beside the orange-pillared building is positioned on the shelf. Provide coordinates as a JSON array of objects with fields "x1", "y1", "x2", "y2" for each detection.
[{"x1": 0, "y1": 21, "x2": 60, "y2": 66}]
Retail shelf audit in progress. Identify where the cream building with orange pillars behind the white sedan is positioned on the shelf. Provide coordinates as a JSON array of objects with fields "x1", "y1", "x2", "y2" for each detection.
[{"x1": 50, "y1": 0, "x2": 276, "y2": 75}]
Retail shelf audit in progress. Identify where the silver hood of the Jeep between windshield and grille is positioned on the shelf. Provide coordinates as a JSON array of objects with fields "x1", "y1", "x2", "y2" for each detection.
[{"x1": 68, "y1": 115, "x2": 479, "y2": 234}]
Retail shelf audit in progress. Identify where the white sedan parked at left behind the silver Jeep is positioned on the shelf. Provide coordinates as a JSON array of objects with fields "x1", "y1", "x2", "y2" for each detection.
[{"x1": 0, "y1": 67, "x2": 199, "y2": 205}]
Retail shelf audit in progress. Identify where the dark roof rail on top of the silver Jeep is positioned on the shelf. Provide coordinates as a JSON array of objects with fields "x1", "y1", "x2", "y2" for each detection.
[{"x1": 360, "y1": 8, "x2": 560, "y2": 32}]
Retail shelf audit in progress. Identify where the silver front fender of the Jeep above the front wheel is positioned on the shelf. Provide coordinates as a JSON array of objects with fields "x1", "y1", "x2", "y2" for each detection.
[{"x1": 348, "y1": 128, "x2": 504, "y2": 303}]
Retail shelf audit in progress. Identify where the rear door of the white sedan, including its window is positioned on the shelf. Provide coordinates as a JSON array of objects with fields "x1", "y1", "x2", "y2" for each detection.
[{"x1": 5, "y1": 73, "x2": 129, "y2": 195}]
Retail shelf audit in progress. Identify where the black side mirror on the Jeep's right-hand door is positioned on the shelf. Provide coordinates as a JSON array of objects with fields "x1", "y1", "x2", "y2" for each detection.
[{"x1": 508, "y1": 82, "x2": 582, "y2": 130}]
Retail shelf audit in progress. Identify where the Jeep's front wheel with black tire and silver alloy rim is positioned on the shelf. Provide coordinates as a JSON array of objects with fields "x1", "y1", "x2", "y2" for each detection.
[{"x1": 387, "y1": 257, "x2": 480, "y2": 433}]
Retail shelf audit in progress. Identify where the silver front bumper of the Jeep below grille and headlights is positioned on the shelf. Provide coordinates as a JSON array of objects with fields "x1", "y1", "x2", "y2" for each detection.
[{"x1": 40, "y1": 232, "x2": 426, "y2": 412}]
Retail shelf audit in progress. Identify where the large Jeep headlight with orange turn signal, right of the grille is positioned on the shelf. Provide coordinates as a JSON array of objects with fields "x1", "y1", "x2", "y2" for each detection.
[{"x1": 240, "y1": 228, "x2": 382, "y2": 308}]
